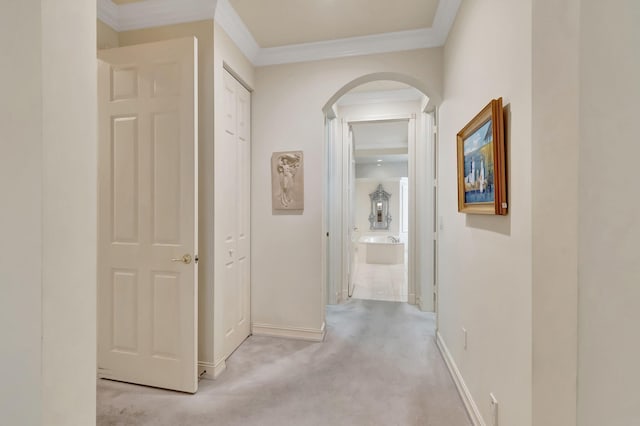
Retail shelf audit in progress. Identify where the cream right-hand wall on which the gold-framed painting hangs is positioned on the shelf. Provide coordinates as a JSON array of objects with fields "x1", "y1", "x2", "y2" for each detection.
[{"x1": 438, "y1": 0, "x2": 532, "y2": 426}]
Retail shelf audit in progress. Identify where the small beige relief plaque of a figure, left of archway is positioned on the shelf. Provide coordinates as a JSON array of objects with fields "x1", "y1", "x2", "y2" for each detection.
[{"x1": 271, "y1": 151, "x2": 304, "y2": 210}]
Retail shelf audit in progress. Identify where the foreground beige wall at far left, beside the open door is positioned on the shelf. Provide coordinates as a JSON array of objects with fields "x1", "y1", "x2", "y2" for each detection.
[{"x1": 0, "y1": 0, "x2": 97, "y2": 426}]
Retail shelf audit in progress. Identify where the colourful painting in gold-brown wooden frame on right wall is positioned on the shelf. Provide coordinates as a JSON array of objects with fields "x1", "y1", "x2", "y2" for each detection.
[{"x1": 457, "y1": 98, "x2": 507, "y2": 215}]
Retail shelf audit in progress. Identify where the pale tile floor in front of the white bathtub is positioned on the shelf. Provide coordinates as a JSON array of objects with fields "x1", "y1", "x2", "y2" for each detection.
[{"x1": 351, "y1": 245, "x2": 408, "y2": 302}]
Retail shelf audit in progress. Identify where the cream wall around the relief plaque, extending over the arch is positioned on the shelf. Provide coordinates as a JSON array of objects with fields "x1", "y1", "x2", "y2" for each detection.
[{"x1": 251, "y1": 49, "x2": 442, "y2": 330}]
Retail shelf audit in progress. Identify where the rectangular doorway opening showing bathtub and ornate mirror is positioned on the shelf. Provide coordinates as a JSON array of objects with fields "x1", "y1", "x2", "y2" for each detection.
[{"x1": 347, "y1": 120, "x2": 410, "y2": 302}]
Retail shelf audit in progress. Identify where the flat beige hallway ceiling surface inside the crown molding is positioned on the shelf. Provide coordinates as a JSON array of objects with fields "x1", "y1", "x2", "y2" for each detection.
[{"x1": 229, "y1": 0, "x2": 446, "y2": 47}]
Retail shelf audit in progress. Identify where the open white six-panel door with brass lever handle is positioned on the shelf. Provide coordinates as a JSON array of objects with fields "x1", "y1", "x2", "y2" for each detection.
[{"x1": 98, "y1": 38, "x2": 198, "y2": 392}]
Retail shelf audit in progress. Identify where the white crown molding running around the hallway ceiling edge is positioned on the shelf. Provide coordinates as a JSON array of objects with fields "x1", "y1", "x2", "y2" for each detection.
[{"x1": 97, "y1": 0, "x2": 462, "y2": 66}]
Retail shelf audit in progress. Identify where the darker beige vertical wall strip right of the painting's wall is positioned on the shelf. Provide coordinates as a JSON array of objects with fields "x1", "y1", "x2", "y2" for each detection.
[{"x1": 528, "y1": 0, "x2": 579, "y2": 426}]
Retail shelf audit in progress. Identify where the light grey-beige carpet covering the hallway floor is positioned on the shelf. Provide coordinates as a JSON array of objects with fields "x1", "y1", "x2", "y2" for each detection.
[{"x1": 97, "y1": 300, "x2": 471, "y2": 426}]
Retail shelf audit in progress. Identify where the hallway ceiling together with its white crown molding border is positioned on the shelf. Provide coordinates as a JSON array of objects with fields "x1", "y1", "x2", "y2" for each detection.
[{"x1": 96, "y1": 0, "x2": 462, "y2": 66}]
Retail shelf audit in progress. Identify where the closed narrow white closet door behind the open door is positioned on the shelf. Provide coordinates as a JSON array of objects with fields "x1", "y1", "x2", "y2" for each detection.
[{"x1": 215, "y1": 70, "x2": 251, "y2": 358}]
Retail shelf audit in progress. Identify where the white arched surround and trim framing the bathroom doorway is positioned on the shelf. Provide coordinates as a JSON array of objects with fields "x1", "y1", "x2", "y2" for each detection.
[{"x1": 323, "y1": 72, "x2": 438, "y2": 311}]
